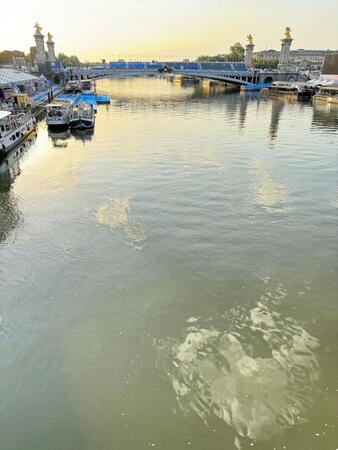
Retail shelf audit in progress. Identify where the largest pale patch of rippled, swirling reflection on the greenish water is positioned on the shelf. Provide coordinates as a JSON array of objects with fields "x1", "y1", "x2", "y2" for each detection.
[{"x1": 159, "y1": 286, "x2": 319, "y2": 448}]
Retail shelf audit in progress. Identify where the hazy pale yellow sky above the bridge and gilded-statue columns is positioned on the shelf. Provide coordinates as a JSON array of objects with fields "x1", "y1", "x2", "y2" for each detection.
[{"x1": 0, "y1": 0, "x2": 338, "y2": 61}]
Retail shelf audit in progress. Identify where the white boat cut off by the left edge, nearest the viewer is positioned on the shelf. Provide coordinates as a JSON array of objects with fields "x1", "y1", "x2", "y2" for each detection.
[{"x1": 0, "y1": 111, "x2": 36, "y2": 157}]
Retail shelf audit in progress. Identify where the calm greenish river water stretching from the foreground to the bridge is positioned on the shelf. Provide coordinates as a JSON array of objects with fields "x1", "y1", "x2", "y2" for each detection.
[{"x1": 0, "y1": 79, "x2": 338, "y2": 450}]
